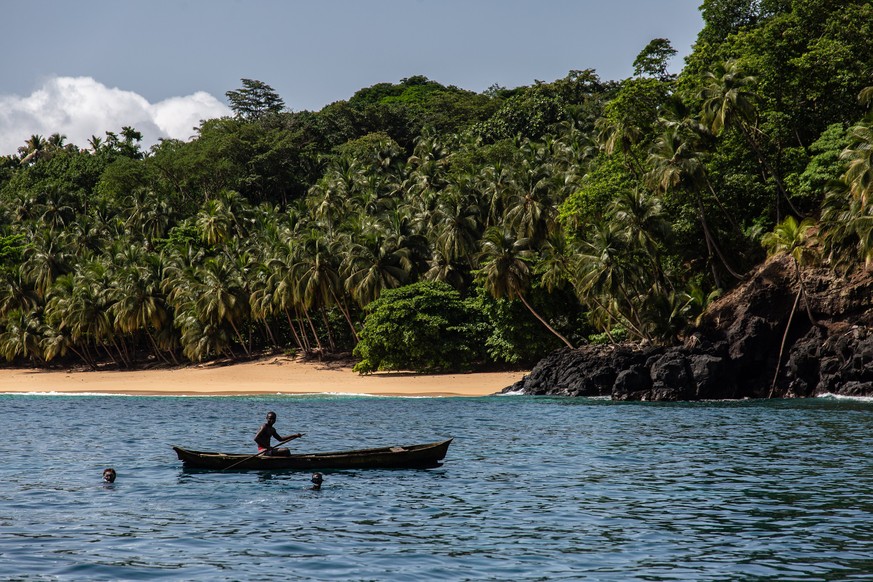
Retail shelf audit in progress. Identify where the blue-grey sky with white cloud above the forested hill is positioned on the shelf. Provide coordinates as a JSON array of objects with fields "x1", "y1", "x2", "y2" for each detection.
[{"x1": 0, "y1": 0, "x2": 703, "y2": 155}]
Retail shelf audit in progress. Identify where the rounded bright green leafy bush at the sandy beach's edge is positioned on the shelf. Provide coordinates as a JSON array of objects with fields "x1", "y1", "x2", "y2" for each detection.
[{"x1": 354, "y1": 282, "x2": 485, "y2": 373}]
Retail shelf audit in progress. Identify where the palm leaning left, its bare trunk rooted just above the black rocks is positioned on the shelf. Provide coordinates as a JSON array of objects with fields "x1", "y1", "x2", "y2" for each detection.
[{"x1": 476, "y1": 226, "x2": 574, "y2": 349}]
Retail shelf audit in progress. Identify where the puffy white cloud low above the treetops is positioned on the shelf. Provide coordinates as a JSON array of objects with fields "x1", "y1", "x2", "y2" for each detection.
[{"x1": 0, "y1": 77, "x2": 231, "y2": 155}]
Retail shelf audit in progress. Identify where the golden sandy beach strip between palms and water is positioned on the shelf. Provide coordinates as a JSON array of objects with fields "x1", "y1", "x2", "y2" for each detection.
[{"x1": 0, "y1": 356, "x2": 525, "y2": 396}]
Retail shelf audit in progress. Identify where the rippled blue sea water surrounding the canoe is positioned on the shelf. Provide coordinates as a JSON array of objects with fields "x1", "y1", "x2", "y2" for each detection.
[{"x1": 0, "y1": 395, "x2": 873, "y2": 581}]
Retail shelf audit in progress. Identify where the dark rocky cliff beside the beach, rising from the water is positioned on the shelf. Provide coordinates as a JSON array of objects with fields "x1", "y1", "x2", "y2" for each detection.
[{"x1": 504, "y1": 256, "x2": 873, "y2": 401}]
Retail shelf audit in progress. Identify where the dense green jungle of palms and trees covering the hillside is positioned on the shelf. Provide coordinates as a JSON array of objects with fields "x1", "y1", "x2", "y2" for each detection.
[{"x1": 0, "y1": 0, "x2": 873, "y2": 373}]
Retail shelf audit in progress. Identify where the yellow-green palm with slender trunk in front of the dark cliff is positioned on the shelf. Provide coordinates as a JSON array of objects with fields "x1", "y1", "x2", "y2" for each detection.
[{"x1": 761, "y1": 216, "x2": 816, "y2": 396}]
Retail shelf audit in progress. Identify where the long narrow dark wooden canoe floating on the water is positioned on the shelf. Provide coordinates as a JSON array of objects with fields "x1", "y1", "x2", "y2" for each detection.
[{"x1": 173, "y1": 439, "x2": 452, "y2": 471}]
